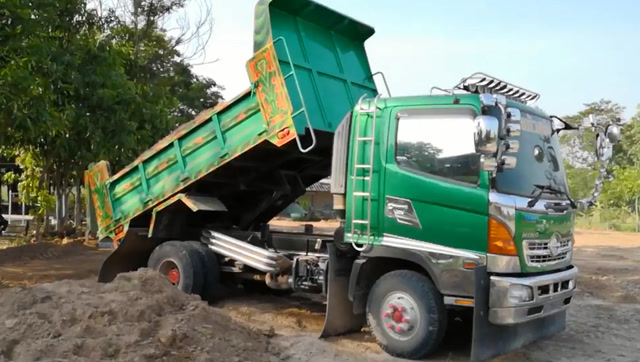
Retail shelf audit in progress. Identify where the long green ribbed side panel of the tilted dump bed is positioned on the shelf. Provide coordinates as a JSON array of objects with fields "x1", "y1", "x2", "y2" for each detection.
[{"x1": 108, "y1": 93, "x2": 267, "y2": 223}]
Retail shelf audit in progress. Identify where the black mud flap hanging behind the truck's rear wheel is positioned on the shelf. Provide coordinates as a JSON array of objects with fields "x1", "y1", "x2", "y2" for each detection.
[{"x1": 98, "y1": 229, "x2": 159, "y2": 283}]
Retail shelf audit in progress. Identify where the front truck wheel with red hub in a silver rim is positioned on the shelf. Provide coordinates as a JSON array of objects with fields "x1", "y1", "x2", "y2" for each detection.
[{"x1": 367, "y1": 270, "x2": 447, "y2": 359}]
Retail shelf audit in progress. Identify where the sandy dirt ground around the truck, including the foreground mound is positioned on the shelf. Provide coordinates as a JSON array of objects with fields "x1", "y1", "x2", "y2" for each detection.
[{"x1": 0, "y1": 229, "x2": 640, "y2": 362}]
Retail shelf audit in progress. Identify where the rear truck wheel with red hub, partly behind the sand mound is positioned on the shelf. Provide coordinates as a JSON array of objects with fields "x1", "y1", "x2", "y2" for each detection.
[{"x1": 147, "y1": 241, "x2": 204, "y2": 295}]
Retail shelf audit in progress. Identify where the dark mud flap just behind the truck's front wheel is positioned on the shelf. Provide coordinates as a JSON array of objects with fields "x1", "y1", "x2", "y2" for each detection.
[{"x1": 320, "y1": 243, "x2": 365, "y2": 338}]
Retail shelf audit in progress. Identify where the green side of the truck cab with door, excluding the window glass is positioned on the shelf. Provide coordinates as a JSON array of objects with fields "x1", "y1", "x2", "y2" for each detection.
[{"x1": 346, "y1": 95, "x2": 489, "y2": 252}]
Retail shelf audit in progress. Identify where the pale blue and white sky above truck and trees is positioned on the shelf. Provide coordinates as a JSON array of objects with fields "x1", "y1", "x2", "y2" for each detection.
[{"x1": 194, "y1": 0, "x2": 640, "y2": 119}]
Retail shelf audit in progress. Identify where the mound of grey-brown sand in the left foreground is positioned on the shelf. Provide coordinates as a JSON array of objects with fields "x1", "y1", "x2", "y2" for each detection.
[{"x1": 0, "y1": 270, "x2": 286, "y2": 362}]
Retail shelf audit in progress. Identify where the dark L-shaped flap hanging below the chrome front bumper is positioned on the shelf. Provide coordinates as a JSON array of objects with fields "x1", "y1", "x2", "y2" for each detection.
[{"x1": 470, "y1": 266, "x2": 567, "y2": 361}]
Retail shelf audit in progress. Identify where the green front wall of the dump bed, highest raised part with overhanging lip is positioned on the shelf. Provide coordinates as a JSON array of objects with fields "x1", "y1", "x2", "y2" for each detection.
[{"x1": 254, "y1": 0, "x2": 378, "y2": 134}]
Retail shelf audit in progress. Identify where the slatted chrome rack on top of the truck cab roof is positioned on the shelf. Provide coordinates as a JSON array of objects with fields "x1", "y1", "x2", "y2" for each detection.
[{"x1": 455, "y1": 72, "x2": 540, "y2": 104}]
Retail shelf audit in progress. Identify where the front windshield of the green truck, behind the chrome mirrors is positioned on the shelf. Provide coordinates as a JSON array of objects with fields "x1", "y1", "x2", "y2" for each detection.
[{"x1": 496, "y1": 112, "x2": 568, "y2": 198}]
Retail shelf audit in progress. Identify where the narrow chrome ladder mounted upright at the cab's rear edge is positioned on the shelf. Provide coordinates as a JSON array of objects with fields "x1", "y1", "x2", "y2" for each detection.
[{"x1": 351, "y1": 94, "x2": 380, "y2": 251}]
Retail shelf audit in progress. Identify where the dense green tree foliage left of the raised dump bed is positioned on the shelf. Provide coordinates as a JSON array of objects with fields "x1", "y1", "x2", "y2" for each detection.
[{"x1": 0, "y1": 0, "x2": 222, "y2": 235}]
